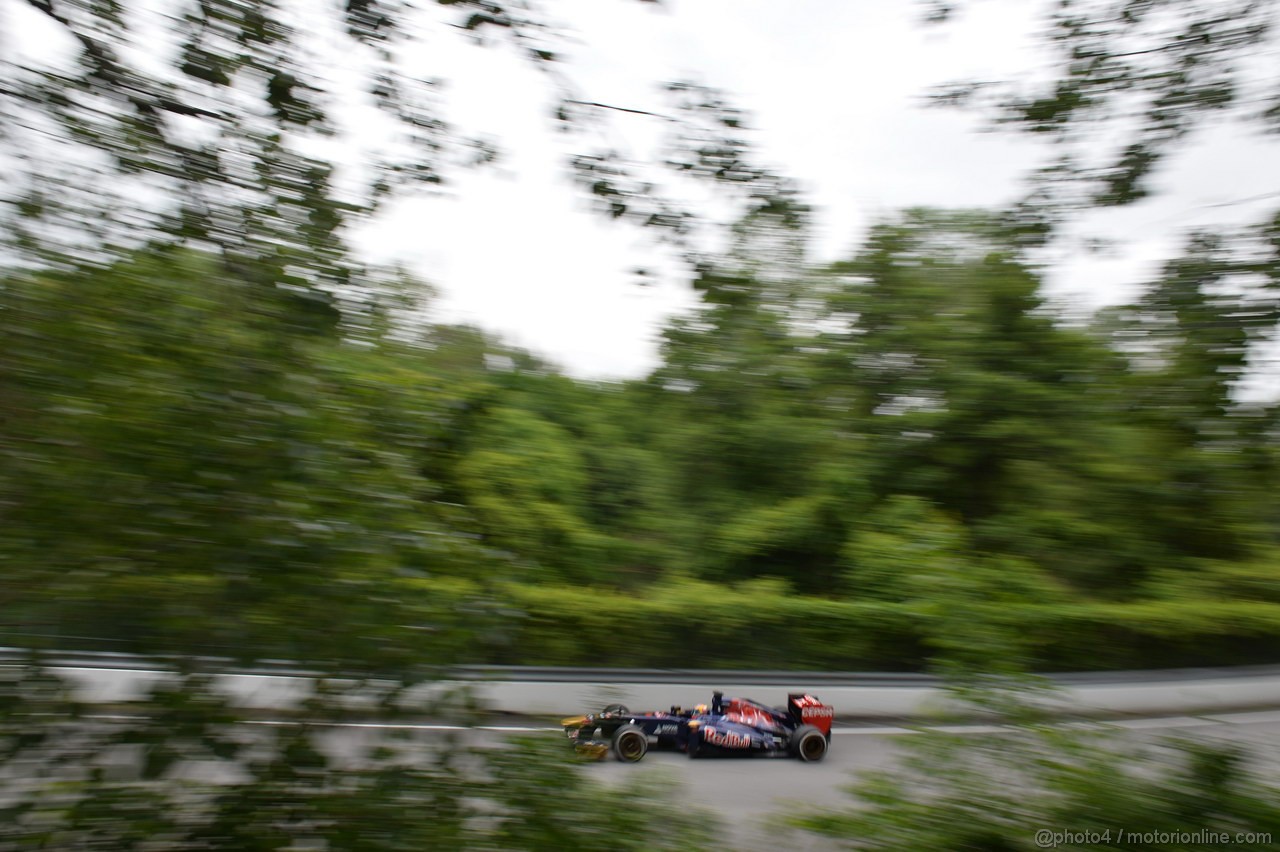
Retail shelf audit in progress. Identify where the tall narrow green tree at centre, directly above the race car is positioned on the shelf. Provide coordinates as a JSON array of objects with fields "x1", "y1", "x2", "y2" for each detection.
[{"x1": 634, "y1": 203, "x2": 864, "y2": 592}]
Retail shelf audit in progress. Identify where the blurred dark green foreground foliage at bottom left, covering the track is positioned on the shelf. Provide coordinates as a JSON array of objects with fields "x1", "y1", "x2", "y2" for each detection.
[{"x1": 0, "y1": 668, "x2": 714, "y2": 852}]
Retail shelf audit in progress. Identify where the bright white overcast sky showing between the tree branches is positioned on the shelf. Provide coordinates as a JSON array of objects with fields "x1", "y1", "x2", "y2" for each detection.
[{"x1": 353, "y1": 0, "x2": 1280, "y2": 377}]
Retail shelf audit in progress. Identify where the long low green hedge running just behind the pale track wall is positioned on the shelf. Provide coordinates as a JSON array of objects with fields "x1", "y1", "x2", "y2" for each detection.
[{"x1": 488, "y1": 580, "x2": 1280, "y2": 675}]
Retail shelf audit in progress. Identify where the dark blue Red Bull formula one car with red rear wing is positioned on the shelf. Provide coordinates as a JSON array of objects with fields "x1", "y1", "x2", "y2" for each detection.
[{"x1": 561, "y1": 692, "x2": 835, "y2": 762}]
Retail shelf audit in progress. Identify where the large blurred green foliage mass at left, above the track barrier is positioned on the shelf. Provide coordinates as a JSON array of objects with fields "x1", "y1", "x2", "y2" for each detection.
[{"x1": 0, "y1": 251, "x2": 488, "y2": 663}]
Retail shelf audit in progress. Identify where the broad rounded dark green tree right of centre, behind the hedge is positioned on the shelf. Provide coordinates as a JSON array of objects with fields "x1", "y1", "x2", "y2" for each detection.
[{"x1": 828, "y1": 211, "x2": 1169, "y2": 590}]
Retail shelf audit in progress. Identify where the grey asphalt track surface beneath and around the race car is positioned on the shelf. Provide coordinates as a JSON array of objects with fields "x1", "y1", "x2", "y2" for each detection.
[{"x1": 204, "y1": 710, "x2": 1280, "y2": 852}]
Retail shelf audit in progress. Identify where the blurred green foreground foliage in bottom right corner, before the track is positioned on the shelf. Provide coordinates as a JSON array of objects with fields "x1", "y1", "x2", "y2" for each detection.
[{"x1": 790, "y1": 727, "x2": 1280, "y2": 851}]
